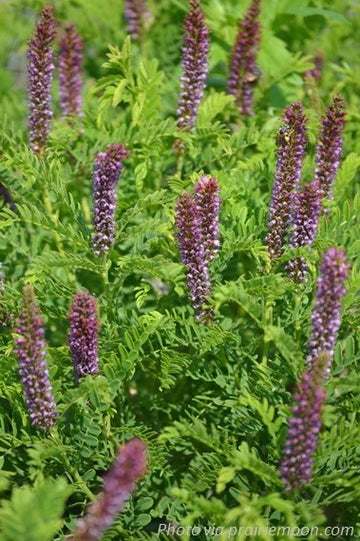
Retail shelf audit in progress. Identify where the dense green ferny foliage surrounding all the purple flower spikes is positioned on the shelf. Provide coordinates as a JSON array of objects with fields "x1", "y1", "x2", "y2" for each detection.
[{"x1": 0, "y1": 0, "x2": 360, "y2": 541}]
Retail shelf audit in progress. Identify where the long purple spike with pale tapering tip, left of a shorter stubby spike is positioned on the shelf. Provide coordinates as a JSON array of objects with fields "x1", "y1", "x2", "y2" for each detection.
[{"x1": 15, "y1": 285, "x2": 57, "y2": 430}]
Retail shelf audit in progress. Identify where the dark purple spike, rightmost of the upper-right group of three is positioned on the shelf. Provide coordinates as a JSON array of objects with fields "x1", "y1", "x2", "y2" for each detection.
[{"x1": 314, "y1": 96, "x2": 345, "y2": 199}]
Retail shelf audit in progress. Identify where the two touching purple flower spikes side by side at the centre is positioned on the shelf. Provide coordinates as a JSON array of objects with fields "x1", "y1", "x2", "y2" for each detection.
[{"x1": 175, "y1": 176, "x2": 220, "y2": 323}]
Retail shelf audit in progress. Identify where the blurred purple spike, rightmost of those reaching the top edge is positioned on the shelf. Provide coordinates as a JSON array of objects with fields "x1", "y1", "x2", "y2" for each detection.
[{"x1": 228, "y1": 0, "x2": 261, "y2": 115}]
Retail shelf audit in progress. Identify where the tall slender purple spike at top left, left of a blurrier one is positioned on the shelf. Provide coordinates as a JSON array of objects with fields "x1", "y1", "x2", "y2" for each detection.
[{"x1": 27, "y1": 6, "x2": 56, "y2": 154}]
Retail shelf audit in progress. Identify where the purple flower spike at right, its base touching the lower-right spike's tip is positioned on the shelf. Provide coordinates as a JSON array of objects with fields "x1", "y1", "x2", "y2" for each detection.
[{"x1": 307, "y1": 248, "x2": 350, "y2": 371}]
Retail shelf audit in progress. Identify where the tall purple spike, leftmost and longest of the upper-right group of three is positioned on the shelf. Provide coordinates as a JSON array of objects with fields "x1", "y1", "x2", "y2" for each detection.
[{"x1": 266, "y1": 102, "x2": 306, "y2": 259}]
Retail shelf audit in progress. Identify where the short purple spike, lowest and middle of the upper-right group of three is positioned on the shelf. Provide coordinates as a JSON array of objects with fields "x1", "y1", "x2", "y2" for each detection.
[{"x1": 287, "y1": 182, "x2": 321, "y2": 282}]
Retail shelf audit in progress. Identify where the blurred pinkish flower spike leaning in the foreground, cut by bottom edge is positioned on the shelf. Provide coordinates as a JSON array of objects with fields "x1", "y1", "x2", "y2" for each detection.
[{"x1": 70, "y1": 438, "x2": 147, "y2": 541}]
